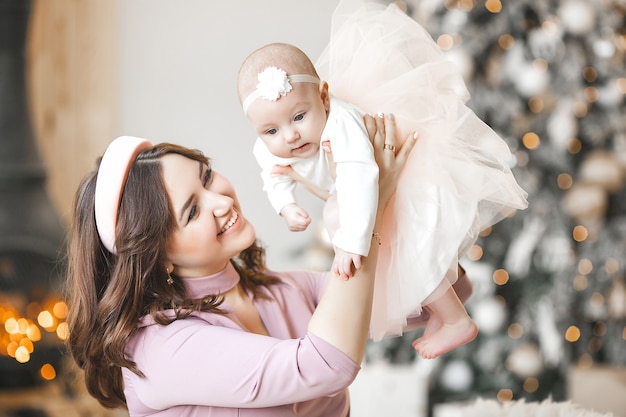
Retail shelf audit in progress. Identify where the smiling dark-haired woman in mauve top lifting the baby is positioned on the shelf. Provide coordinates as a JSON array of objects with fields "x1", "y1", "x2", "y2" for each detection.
[{"x1": 68, "y1": 116, "x2": 460, "y2": 416}]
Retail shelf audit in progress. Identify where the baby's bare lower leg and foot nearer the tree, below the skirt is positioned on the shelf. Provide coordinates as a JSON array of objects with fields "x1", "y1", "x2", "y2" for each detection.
[{"x1": 413, "y1": 287, "x2": 478, "y2": 359}]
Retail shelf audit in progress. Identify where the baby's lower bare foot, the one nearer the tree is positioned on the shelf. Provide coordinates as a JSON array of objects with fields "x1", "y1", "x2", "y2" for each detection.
[{"x1": 413, "y1": 318, "x2": 478, "y2": 359}]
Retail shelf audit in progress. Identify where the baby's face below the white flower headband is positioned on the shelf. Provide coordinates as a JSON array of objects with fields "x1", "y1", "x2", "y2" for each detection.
[{"x1": 247, "y1": 83, "x2": 327, "y2": 158}]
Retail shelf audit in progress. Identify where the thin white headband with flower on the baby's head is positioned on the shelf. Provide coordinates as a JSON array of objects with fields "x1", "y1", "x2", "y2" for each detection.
[{"x1": 242, "y1": 67, "x2": 320, "y2": 113}]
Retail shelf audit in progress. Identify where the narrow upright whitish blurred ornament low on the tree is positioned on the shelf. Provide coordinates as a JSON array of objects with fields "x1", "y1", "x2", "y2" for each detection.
[{"x1": 535, "y1": 295, "x2": 564, "y2": 367}]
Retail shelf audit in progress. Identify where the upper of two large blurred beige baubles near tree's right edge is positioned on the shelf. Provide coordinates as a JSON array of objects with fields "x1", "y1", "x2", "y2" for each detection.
[{"x1": 579, "y1": 150, "x2": 624, "y2": 193}]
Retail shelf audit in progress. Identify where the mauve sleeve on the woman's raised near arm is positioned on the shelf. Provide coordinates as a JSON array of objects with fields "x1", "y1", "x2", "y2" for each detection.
[{"x1": 128, "y1": 317, "x2": 360, "y2": 410}]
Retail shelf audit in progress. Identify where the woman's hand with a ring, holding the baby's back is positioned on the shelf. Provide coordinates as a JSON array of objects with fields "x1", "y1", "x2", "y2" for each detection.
[{"x1": 363, "y1": 114, "x2": 418, "y2": 210}]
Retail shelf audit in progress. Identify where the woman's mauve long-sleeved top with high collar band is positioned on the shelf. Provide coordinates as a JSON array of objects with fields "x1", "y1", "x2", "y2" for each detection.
[{"x1": 122, "y1": 264, "x2": 360, "y2": 417}]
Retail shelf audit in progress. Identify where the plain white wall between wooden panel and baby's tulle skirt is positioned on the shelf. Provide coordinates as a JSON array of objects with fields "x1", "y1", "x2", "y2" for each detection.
[{"x1": 117, "y1": 0, "x2": 338, "y2": 269}]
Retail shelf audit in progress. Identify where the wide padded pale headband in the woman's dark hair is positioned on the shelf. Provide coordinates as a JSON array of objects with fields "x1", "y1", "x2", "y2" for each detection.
[{"x1": 94, "y1": 136, "x2": 152, "y2": 254}]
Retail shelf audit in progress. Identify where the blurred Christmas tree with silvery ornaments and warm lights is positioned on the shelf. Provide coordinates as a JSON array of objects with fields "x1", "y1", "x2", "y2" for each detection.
[{"x1": 368, "y1": 0, "x2": 626, "y2": 410}]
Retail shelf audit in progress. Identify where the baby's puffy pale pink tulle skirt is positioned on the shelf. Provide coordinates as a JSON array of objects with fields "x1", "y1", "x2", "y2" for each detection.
[{"x1": 316, "y1": 0, "x2": 528, "y2": 340}]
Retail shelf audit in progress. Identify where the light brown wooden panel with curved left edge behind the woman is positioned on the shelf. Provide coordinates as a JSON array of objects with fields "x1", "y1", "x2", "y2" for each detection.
[{"x1": 27, "y1": 0, "x2": 117, "y2": 222}]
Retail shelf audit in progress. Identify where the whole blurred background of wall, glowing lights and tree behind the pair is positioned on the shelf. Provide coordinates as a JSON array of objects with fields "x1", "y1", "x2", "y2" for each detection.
[{"x1": 0, "y1": 0, "x2": 626, "y2": 417}]
